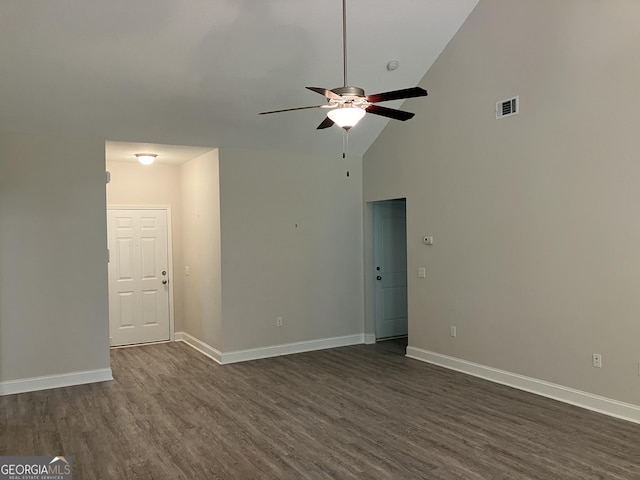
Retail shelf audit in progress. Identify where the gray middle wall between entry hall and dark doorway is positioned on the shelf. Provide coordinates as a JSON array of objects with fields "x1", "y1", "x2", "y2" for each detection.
[{"x1": 220, "y1": 149, "x2": 364, "y2": 352}]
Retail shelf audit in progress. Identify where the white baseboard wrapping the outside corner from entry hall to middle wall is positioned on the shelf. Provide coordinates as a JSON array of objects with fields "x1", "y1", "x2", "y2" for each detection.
[{"x1": 175, "y1": 332, "x2": 365, "y2": 365}]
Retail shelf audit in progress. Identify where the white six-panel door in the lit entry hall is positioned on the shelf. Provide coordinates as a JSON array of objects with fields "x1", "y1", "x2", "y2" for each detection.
[{"x1": 107, "y1": 209, "x2": 170, "y2": 346}]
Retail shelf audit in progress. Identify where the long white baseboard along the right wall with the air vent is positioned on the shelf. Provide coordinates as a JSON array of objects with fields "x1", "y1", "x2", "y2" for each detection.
[{"x1": 407, "y1": 347, "x2": 640, "y2": 423}]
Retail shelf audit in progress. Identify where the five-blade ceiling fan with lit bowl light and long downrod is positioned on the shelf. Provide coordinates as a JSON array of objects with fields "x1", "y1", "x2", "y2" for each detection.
[{"x1": 260, "y1": 0, "x2": 427, "y2": 131}]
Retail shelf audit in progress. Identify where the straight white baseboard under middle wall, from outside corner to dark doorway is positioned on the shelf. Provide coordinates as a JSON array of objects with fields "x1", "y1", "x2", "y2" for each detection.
[{"x1": 222, "y1": 333, "x2": 364, "y2": 364}]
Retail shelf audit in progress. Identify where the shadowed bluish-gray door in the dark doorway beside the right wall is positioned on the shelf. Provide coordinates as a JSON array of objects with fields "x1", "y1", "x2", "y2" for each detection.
[{"x1": 373, "y1": 200, "x2": 408, "y2": 340}]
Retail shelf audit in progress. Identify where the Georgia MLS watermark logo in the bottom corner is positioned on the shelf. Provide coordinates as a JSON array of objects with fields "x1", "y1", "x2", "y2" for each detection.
[{"x1": 0, "y1": 457, "x2": 73, "y2": 480}]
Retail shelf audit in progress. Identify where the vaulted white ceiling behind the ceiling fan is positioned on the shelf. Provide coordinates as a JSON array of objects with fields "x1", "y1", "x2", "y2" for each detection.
[{"x1": 0, "y1": 0, "x2": 478, "y2": 155}]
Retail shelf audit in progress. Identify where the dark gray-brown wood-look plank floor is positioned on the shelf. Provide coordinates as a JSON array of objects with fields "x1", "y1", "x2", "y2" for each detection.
[{"x1": 0, "y1": 341, "x2": 640, "y2": 480}]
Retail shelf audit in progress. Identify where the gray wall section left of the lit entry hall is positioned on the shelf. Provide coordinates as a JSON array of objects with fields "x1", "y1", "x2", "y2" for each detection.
[{"x1": 0, "y1": 134, "x2": 109, "y2": 381}]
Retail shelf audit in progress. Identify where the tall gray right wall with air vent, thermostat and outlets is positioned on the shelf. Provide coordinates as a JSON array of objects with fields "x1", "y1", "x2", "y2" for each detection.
[{"x1": 363, "y1": 0, "x2": 640, "y2": 405}]
